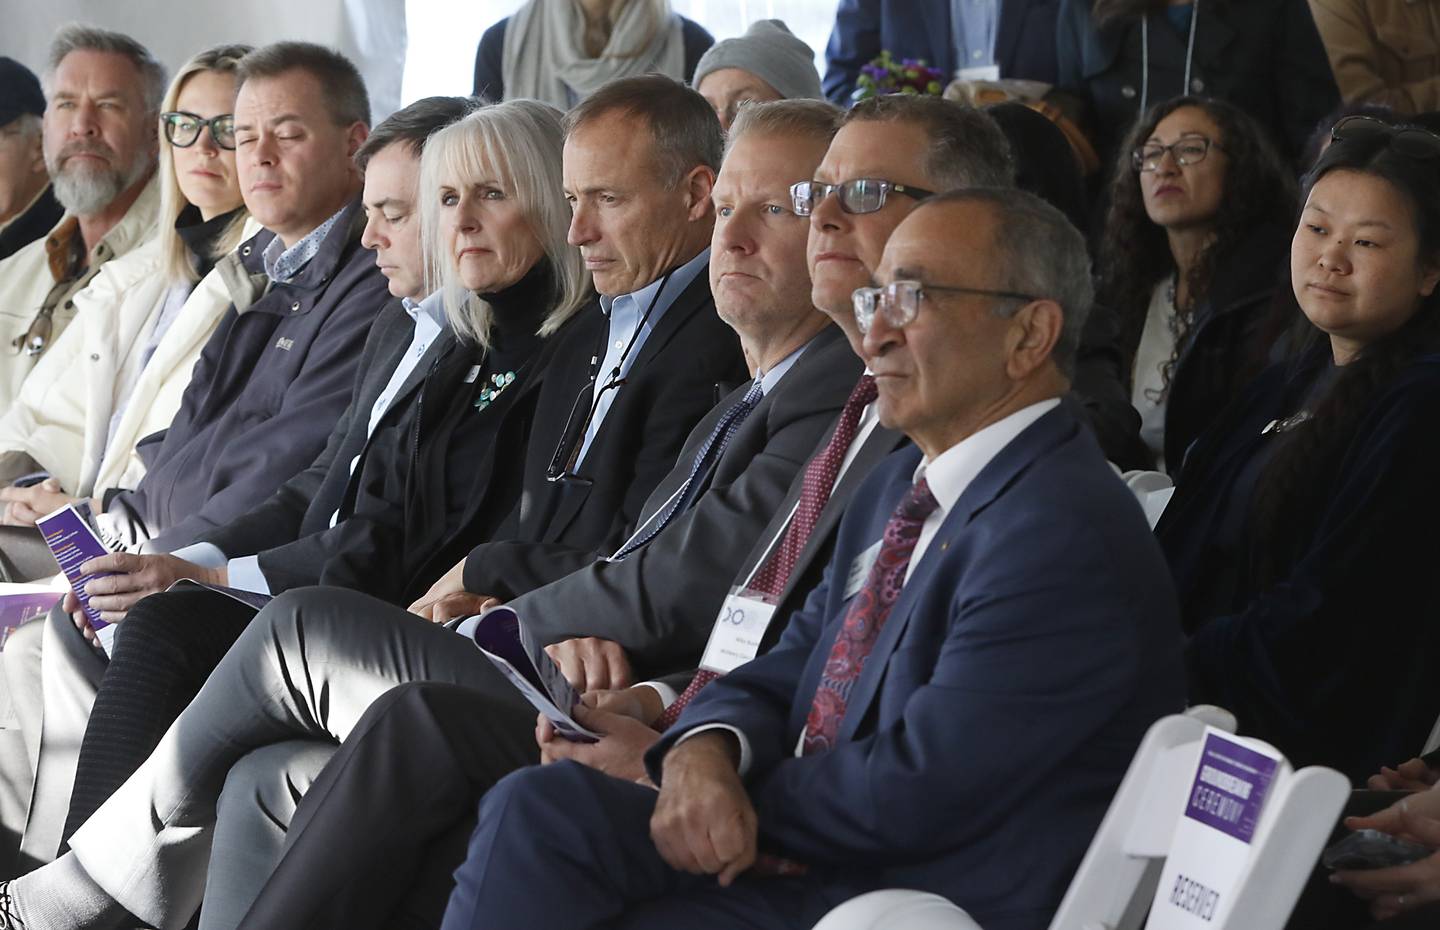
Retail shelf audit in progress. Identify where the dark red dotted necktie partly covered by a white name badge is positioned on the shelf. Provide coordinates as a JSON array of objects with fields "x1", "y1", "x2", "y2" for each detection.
[{"x1": 655, "y1": 374, "x2": 877, "y2": 730}]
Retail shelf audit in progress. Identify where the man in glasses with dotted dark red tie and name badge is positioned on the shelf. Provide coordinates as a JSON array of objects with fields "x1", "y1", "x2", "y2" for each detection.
[{"x1": 224, "y1": 98, "x2": 1012, "y2": 927}]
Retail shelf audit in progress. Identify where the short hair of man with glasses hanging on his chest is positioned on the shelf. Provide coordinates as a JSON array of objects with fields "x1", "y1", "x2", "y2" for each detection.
[{"x1": 564, "y1": 75, "x2": 724, "y2": 189}]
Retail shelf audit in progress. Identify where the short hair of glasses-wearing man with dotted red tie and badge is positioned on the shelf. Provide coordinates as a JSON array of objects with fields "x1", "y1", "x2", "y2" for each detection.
[{"x1": 842, "y1": 94, "x2": 1015, "y2": 191}]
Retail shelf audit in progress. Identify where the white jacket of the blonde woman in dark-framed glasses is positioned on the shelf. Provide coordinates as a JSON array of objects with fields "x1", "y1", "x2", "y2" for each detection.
[{"x1": 0, "y1": 222, "x2": 259, "y2": 497}]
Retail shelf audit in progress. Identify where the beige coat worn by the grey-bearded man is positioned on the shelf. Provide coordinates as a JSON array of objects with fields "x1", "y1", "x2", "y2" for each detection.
[{"x1": 0, "y1": 179, "x2": 160, "y2": 412}]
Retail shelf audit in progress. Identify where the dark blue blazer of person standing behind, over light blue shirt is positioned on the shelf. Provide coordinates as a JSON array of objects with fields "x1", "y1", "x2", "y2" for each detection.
[{"x1": 824, "y1": 0, "x2": 1060, "y2": 105}]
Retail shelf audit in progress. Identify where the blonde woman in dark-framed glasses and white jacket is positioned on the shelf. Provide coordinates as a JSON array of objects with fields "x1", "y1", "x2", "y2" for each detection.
[{"x1": 0, "y1": 45, "x2": 258, "y2": 582}]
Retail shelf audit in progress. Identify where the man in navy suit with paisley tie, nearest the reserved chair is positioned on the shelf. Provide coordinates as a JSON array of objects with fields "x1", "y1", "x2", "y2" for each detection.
[{"x1": 445, "y1": 189, "x2": 1184, "y2": 930}]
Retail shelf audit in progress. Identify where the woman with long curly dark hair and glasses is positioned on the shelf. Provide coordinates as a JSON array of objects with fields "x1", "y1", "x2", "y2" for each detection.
[{"x1": 1097, "y1": 96, "x2": 1295, "y2": 472}]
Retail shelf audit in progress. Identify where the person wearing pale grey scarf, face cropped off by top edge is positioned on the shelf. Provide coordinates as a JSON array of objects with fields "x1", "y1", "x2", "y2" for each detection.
[{"x1": 474, "y1": 0, "x2": 714, "y2": 109}]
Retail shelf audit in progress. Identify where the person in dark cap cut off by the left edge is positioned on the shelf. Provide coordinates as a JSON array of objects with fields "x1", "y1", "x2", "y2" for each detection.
[{"x1": 0, "y1": 56, "x2": 65, "y2": 259}]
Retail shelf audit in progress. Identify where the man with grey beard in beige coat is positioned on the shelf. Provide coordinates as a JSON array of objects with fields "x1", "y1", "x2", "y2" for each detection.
[{"x1": 0, "y1": 24, "x2": 166, "y2": 409}]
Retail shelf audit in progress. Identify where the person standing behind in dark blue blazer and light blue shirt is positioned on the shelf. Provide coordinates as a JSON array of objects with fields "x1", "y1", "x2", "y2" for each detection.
[{"x1": 824, "y1": 0, "x2": 1060, "y2": 104}]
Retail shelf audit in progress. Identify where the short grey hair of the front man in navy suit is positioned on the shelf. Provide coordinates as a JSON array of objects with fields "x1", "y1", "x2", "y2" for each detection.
[{"x1": 916, "y1": 187, "x2": 1094, "y2": 376}]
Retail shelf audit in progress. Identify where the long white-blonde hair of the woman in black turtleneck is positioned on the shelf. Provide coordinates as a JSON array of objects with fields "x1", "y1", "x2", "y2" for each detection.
[{"x1": 419, "y1": 99, "x2": 590, "y2": 347}]
